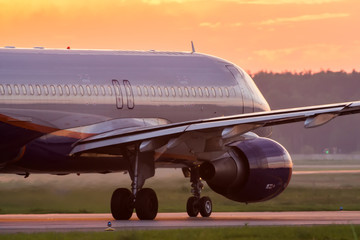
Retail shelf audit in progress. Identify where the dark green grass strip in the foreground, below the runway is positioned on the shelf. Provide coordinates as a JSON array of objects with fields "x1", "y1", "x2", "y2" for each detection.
[{"x1": 0, "y1": 225, "x2": 360, "y2": 240}]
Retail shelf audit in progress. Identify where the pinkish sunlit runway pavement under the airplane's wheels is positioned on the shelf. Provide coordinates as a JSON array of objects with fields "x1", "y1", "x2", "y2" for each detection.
[{"x1": 0, "y1": 211, "x2": 360, "y2": 233}]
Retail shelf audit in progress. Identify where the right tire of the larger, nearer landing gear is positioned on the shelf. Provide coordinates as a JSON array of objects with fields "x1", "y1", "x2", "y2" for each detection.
[{"x1": 135, "y1": 188, "x2": 158, "y2": 220}]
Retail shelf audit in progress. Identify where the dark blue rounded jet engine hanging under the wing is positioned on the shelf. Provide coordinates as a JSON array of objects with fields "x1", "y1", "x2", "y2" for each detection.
[{"x1": 200, "y1": 137, "x2": 292, "y2": 203}]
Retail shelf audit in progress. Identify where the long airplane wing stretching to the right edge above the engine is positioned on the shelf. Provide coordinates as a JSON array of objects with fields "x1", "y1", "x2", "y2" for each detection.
[{"x1": 70, "y1": 101, "x2": 360, "y2": 155}]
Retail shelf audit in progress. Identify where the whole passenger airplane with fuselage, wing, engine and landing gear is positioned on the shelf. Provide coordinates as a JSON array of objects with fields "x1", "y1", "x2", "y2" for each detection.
[{"x1": 0, "y1": 47, "x2": 360, "y2": 220}]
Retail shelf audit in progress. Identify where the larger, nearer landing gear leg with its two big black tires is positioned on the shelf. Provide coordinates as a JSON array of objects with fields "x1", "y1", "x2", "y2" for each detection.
[{"x1": 111, "y1": 145, "x2": 158, "y2": 220}]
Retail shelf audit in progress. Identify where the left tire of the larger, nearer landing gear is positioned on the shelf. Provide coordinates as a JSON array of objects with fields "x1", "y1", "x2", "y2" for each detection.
[{"x1": 111, "y1": 188, "x2": 134, "y2": 220}]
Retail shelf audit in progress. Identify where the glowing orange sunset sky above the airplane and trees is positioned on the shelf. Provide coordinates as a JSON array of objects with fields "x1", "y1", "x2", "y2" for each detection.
[{"x1": 0, "y1": 0, "x2": 360, "y2": 72}]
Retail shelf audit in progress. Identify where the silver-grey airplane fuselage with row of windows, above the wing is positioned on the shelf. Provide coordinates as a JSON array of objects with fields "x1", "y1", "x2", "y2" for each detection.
[{"x1": 0, "y1": 48, "x2": 270, "y2": 171}]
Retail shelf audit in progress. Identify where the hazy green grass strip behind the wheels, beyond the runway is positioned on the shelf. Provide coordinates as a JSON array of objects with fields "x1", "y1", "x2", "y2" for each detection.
[{"x1": 0, "y1": 187, "x2": 360, "y2": 214}]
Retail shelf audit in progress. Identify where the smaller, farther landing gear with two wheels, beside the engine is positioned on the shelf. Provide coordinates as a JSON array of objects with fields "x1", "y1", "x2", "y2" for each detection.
[{"x1": 186, "y1": 166, "x2": 212, "y2": 217}]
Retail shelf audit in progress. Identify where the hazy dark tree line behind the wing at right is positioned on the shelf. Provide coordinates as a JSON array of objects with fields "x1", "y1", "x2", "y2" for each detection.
[{"x1": 252, "y1": 70, "x2": 360, "y2": 154}]
